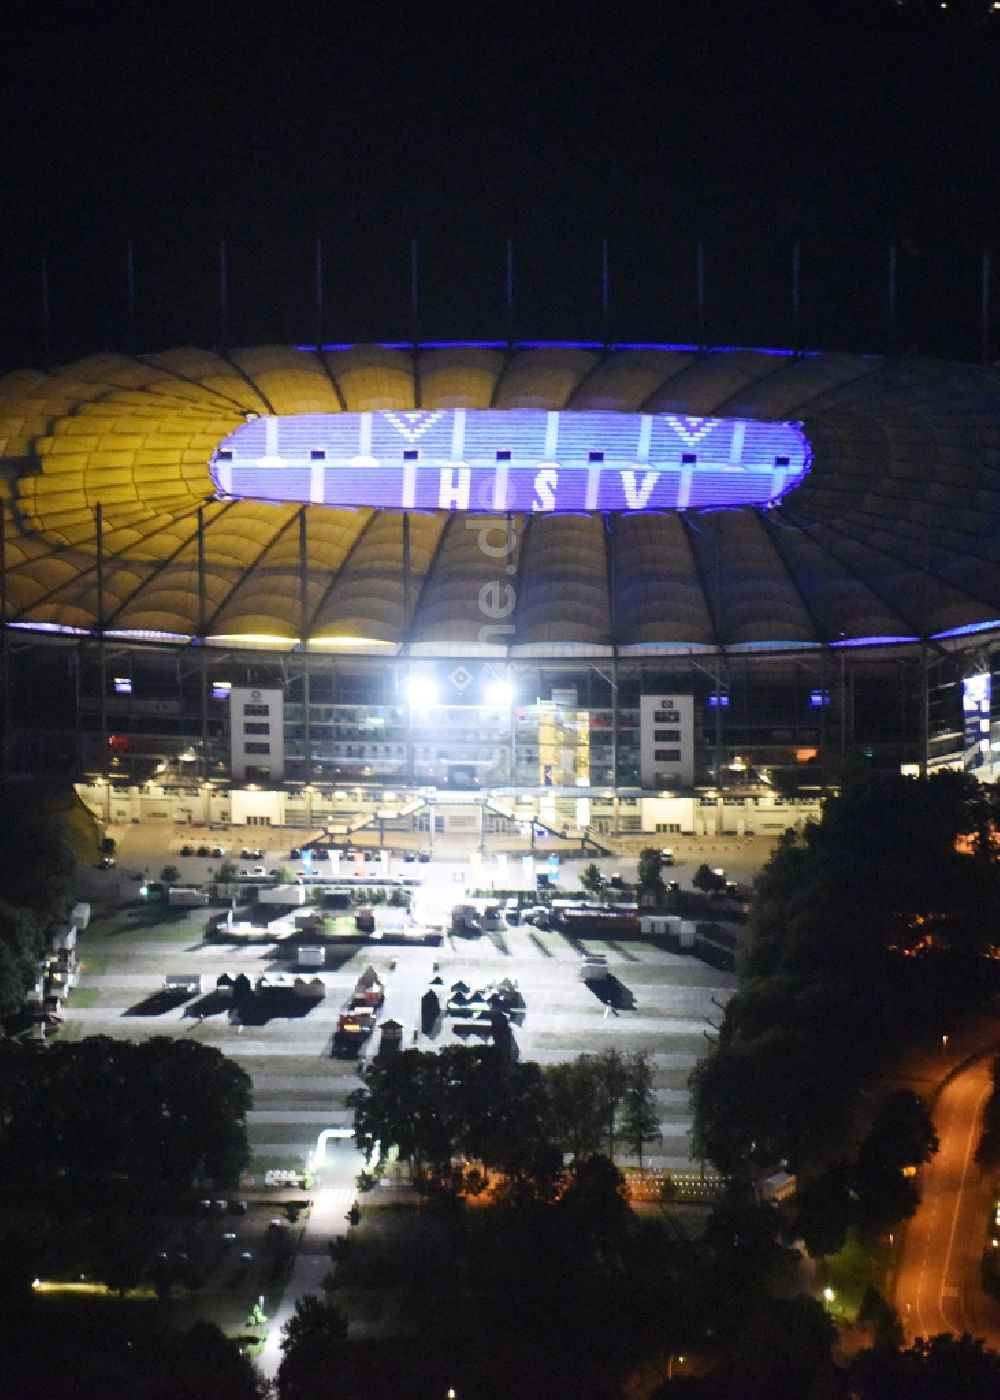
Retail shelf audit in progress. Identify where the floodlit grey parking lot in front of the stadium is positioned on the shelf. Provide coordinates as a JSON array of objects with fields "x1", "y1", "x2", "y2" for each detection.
[{"x1": 73, "y1": 826, "x2": 735, "y2": 1173}]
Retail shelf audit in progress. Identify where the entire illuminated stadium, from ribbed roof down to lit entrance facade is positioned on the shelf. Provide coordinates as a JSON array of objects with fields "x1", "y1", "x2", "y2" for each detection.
[{"x1": 0, "y1": 342, "x2": 1000, "y2": 836}]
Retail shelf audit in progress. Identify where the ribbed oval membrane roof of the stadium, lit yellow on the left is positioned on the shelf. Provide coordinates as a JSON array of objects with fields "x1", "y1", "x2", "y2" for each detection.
[{"x1": 0, "y1": 346, "x2": 1000, "y2": 657}]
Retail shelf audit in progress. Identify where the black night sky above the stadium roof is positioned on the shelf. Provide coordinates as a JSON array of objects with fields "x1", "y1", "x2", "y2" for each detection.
[{"x1": 0, "y1": 0, "x2": 1000, "y2": 353}]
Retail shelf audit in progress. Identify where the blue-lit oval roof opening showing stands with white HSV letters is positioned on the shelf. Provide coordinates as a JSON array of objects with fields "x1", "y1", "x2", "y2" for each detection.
[{"x1": 210, "y1": 409, "x2": 810, "y2": 512}]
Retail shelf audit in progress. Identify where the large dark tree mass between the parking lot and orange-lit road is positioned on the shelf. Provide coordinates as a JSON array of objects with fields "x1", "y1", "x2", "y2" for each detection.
[{"x1": 692, "y1": 773, "x2": 1000, "y2": 1170}]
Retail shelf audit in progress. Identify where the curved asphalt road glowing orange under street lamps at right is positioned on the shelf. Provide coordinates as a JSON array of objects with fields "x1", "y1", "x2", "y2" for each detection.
[{"x1": 896, "y1": 1057, "x2": 1000, "y2": 1348}]
